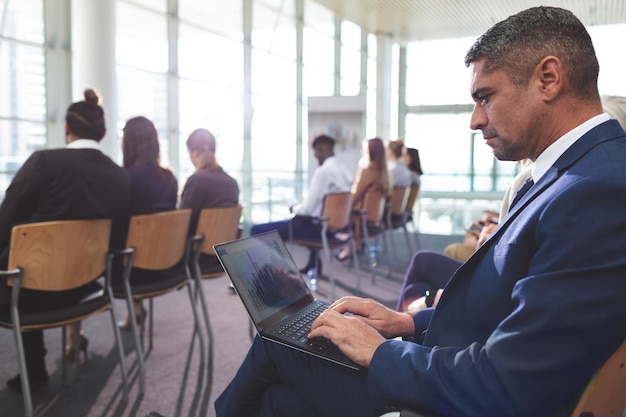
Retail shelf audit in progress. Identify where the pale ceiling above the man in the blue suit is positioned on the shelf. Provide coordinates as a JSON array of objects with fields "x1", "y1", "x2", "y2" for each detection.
[{"x1": 316, "y1": 0, "x2": 626, "y2": 43}]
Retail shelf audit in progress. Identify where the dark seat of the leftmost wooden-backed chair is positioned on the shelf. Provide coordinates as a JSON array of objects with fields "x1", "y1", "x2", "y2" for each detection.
[{"x1": 0, "y1": 297, "x2": 111, "y2": 329}]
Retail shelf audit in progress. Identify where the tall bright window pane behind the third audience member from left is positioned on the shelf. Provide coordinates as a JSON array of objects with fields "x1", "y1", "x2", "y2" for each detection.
[{"x1": 178, "y1": 9, "x2": 244, "y2": 185}]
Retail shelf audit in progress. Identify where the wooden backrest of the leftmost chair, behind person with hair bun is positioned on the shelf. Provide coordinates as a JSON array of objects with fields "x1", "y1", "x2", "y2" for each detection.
[{"x1": 8, "y1": 219, "x2": 111, "y2": 291}]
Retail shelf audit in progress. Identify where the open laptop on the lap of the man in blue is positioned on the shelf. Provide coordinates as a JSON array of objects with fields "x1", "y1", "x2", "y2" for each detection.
[{"x1": 213, "y1": 230, "x2": 360, "y2": 370}]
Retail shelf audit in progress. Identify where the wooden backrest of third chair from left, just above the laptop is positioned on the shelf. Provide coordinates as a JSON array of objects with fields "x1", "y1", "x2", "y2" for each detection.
[{"x1": 196, "y1": 206, "x2": 243, "y2": 255}]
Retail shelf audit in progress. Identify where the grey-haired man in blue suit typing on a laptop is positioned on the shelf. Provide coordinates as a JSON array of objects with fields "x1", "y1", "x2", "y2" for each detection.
[{"x1": 216, "y1": 7, "x2": 626, "y2": 417}]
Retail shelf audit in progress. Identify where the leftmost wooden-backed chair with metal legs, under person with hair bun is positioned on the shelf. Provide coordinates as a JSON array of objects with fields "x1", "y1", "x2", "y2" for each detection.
[{"x1": 0, "y1": 219, "x2": 128, "y2": 417}]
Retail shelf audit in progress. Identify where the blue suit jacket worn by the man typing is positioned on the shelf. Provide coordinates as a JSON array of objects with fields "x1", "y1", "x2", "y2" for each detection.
[{"x1": 368, "y1": 120, "x2": 626, "y2": 417}]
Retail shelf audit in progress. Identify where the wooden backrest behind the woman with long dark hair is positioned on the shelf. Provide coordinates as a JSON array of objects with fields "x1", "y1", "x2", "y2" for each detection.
[{"x1": 126, "y1": 209, "x2": 191, "y2": 270}]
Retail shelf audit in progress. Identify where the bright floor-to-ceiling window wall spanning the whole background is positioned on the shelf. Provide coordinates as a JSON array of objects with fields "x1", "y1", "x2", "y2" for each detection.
[{"x1": 0, "y1": 0, "x2": 626, "y2": 233}]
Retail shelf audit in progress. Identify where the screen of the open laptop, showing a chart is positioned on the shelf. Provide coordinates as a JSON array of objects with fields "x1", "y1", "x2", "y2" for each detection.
[{"x1": 214, "y1": 230, "x2": 313, "y2": 323}]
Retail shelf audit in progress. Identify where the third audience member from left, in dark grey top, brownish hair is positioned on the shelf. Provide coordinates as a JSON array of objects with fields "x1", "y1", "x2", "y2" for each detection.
[{"x1": 180, "y1": 129, "x2": 239, "y2": 274}]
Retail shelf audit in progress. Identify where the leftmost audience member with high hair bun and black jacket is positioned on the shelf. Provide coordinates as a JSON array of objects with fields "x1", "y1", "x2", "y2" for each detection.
[{"x1": 0, "y1": 89, "x2": 130, "y2": 391}]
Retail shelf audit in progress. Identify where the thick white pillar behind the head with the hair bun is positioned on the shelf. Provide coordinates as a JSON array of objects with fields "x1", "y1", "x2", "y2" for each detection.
[{"x1": 68, "y1": 0, "x2": 121, "y2": 162}]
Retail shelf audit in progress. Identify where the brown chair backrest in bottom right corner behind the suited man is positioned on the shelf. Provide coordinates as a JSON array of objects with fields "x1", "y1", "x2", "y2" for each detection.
[{"x1": 572, "y1": 341, "x2": 626, "y2": 417}]
